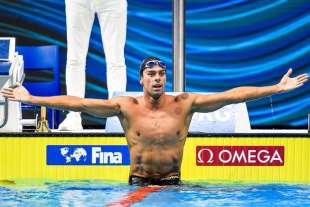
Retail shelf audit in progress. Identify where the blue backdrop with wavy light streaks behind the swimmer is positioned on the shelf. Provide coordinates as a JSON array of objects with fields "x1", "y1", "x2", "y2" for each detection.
[{"x1": 0, "y1": 0, "x2": 310, "y2": 128}]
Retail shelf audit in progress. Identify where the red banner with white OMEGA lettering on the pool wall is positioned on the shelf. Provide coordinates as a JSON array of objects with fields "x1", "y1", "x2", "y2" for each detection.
[{"x1": 196, "y1": 146, "x2": 284, "y2": 166}]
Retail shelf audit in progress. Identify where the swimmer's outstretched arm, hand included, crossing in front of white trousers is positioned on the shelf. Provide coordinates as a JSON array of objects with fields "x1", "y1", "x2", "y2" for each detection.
[{"x1": 1, "y1": 85, "x2": 121, "y2": 117}]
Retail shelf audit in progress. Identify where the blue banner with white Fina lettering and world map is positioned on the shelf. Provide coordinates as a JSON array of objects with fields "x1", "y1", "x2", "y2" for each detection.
[{"x1": 46, "y1": 145, "x2": 130, "y2": 165}]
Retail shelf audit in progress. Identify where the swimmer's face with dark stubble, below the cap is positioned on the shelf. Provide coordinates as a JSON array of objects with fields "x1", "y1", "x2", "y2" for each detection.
[{"x1": 140, "y1": 65, "x2": 166, "y2": 98}]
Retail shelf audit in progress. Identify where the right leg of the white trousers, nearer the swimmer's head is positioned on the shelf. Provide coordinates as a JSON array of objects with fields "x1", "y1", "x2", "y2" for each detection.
[{"x1": 96, "y1": 0, "x2": 127, "y2": 98}]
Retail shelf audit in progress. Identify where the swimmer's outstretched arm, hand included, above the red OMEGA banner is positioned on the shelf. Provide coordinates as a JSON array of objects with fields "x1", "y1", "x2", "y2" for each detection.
[{"x1": 191, "y1": 69, "x2": 308, "y2": 112}]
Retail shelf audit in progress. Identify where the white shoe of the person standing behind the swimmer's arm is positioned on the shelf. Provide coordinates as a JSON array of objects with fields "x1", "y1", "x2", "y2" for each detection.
[{"x1": 58, "y1": 112, "x2": 83, "y2": 131}]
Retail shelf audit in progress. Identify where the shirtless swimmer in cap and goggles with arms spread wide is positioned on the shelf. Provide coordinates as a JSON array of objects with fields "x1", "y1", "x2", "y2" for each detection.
[{"x1": 2, "y1": 57, "x2": 308, "y2": 185}]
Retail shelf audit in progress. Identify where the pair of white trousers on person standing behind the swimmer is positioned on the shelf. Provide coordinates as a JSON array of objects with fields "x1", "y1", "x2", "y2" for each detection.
[{"x1": 66, "y1": 0, "x2": 127, "y2": 98}]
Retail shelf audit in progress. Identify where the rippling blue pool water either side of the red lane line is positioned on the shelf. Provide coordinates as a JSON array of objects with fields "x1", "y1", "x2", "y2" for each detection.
[{"x1": 0, "y1": 181, "x2": 310, "y2": 207}]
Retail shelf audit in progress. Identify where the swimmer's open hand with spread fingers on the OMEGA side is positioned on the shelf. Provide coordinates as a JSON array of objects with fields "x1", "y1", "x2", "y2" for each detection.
[{"x1": 278, "y1": 68, "x2": 309, "y2": 92}]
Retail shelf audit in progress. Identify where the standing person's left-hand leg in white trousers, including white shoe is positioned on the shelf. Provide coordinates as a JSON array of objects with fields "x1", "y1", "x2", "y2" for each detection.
[{"x1": 58, "y1": 0, "x2": 95, "y2": 131}]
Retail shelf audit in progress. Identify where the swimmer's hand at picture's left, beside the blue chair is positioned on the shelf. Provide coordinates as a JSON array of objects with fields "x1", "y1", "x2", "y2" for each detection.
[{"x1": 1, "y1": 83, "x2": 31, "y2": 102}]
